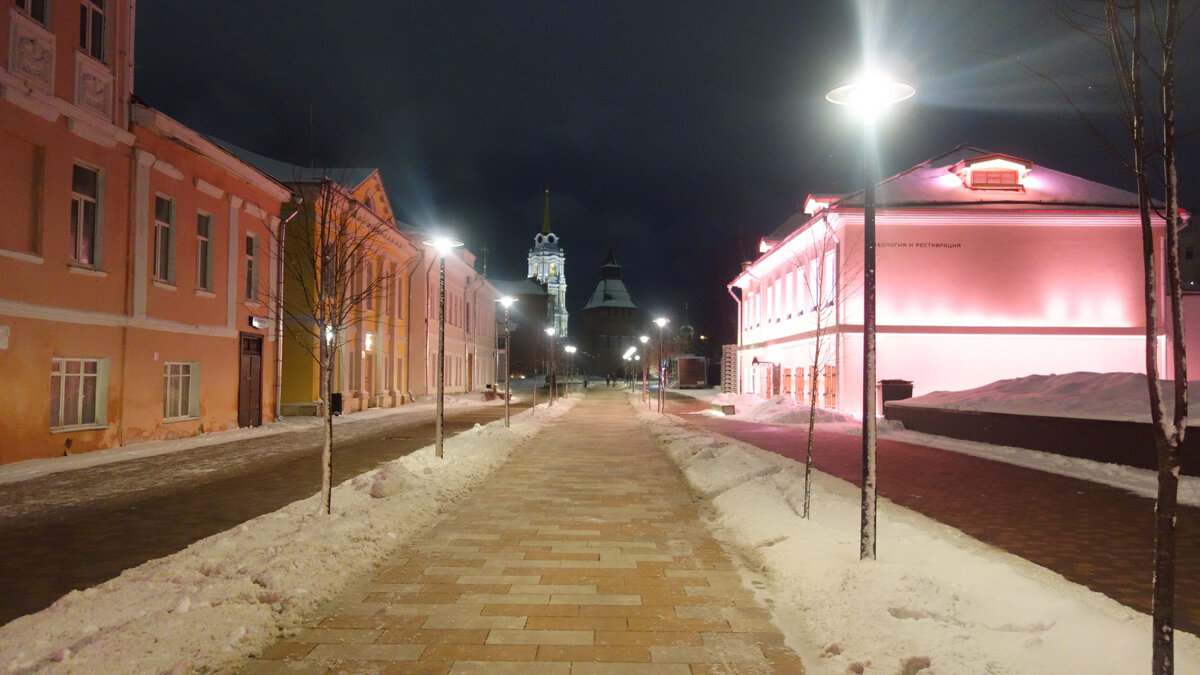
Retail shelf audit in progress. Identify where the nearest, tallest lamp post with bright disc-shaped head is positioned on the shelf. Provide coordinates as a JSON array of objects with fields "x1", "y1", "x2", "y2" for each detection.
[{"x1": 826, "y1": 74, "x2": 917, "y2": 560}]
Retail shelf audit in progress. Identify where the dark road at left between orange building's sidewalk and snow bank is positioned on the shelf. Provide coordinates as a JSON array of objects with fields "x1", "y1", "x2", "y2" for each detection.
[{"x1": 0, "y1": 402, "x2": 528, "y2": 625}]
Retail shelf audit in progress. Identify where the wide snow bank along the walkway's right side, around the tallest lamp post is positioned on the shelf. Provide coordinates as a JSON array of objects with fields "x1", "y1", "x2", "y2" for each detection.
[{"x1": 642, "y1": 403, "x2": 1200, "y2": 675}]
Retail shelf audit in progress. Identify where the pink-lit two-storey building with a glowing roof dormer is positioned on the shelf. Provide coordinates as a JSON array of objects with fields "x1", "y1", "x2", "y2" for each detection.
[{"x1": 730, "y1": 145, "x2": 1185, "y2": 413}]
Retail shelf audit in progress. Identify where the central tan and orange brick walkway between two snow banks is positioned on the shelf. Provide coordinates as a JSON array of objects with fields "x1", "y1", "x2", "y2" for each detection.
[{"x1": 245, "y1": 389, "x2": 804, "y2": 675}]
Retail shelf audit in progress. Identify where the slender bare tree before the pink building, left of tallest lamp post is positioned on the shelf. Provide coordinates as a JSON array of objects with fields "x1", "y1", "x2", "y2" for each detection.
[{"x1": 791, "y1": 219, "x2": 862, "y2": 518}]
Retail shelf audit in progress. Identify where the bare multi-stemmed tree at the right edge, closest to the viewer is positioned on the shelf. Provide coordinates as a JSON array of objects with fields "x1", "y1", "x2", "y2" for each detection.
[{"x1": 1060, "y1": 0, "x2": 1196, "y2": 675}]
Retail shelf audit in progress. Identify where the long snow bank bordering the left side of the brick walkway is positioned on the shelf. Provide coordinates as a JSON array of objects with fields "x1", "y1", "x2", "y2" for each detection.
[{"x1": 0, "y1": 399, "x2": 574, "y2": 675}]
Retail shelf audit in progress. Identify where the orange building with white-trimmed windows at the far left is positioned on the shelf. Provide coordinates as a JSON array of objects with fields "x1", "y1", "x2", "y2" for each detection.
[{"x1": 0, "y1": 0, "x2": 287, "y2": 462}]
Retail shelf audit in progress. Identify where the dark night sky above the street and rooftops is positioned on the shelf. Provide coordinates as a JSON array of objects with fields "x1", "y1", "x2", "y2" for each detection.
[{"x1": 134, "y1": 0, "x2": 1200, "y2": 344}]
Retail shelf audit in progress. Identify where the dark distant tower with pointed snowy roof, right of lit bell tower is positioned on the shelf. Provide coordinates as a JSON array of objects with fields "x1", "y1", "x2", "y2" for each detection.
[{"x1": 580, "y1": 250, "x2": 642, "y2": 375}]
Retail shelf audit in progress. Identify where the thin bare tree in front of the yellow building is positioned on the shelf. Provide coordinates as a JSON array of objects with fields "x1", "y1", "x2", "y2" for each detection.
[{"x1": 272, "y1": 175, "x2": 398, "y2": 515}]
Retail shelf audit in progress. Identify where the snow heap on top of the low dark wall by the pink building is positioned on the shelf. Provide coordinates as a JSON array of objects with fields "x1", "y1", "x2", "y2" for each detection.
[{"x1": 904, "y1": 372, "x2": 1200, "y2": 422}]
